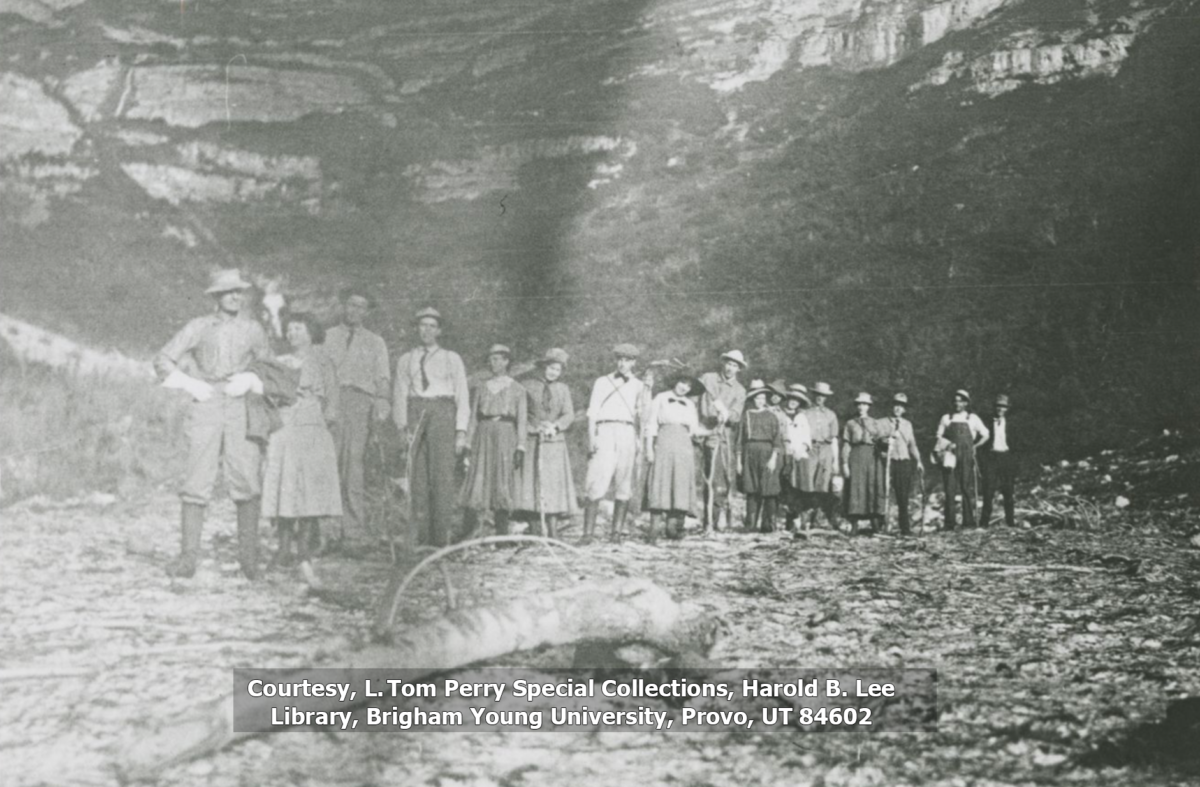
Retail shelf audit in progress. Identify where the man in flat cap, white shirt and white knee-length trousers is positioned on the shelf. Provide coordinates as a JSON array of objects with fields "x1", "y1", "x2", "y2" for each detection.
[{"x1": 583, "y1": 343, "x2": 649, "y2": 541}]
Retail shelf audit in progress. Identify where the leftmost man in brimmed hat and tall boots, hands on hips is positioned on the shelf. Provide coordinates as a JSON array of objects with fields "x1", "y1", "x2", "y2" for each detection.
[{"x1": 154, "y1": 269, "x2": 271, "y2": 578}]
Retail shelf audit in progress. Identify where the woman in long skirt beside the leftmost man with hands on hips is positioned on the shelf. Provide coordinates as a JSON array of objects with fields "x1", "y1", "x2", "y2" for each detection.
[{"x1": 263, "y1": 313, "x2": 342, "y2": 565}]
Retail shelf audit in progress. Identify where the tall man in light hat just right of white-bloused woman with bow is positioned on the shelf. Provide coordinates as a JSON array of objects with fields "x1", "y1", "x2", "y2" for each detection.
[{"x1": 700, "y1": 350, "x2": 746, "y2": 531}]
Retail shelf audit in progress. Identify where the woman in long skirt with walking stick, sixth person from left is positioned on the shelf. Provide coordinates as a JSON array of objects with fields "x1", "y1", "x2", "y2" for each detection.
[{"x1": 516, "y1": 347, "x2": 580, "y2": 539}]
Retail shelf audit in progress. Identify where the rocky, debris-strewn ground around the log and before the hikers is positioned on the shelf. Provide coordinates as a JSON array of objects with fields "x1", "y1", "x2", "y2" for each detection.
[{"x1": 0, "y1": 434, "x2": 1200, "y2": 786}]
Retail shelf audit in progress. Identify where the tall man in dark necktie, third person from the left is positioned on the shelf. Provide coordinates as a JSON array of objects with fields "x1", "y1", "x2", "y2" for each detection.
[{"x1": 324, "y1": 286, "x2": 391, "y2": 549}]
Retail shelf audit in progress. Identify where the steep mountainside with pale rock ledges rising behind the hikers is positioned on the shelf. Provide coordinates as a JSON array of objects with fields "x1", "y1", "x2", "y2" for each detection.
[{"x1": 0, "y1": 0, "x2": 1196, "y2": 448}]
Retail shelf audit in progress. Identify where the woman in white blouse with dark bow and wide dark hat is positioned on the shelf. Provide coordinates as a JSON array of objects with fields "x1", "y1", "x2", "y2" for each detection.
[{"x1": 646, "y1": 372, "x2": 703, "y2": 543}]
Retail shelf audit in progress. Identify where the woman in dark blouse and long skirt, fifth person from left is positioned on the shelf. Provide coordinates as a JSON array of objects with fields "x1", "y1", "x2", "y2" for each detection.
[{"x1": 462, "y1": 344, "x2": 529, "y2": 535}]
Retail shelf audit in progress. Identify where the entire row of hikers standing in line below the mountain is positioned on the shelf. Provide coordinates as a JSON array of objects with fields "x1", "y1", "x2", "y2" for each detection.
[{"x1": 147, "y1": 270, "x2": 1015, "y2": 577}]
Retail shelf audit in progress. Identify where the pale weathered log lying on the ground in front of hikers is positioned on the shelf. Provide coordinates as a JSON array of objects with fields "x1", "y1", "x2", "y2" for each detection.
[{"x1": 119, "y1": 579, "x2": 720, "y2": 780}]
